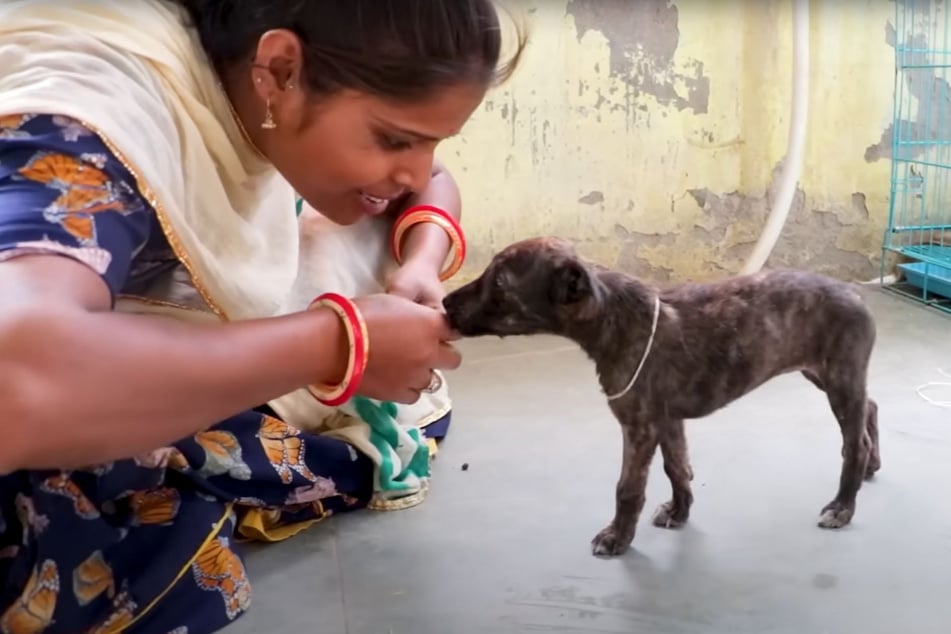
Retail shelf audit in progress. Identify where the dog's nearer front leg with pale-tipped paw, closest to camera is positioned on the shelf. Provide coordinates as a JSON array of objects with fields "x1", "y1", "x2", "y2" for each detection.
[{"x1": 591, "y1": 420, "x2": 658, "y2": 556}]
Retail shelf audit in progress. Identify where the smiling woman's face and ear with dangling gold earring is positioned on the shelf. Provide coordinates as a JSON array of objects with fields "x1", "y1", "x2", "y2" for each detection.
[{"x1": 238, "y1": 32, "x2": 486, "y2": 225}]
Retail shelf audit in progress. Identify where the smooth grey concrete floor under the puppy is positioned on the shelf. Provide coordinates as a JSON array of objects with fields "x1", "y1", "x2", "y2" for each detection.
[{"x1": 227, "y1": 288, "x2": 951, "y2": 634}]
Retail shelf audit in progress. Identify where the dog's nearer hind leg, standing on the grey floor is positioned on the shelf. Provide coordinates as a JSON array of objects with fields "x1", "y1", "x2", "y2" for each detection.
[{"x1": 818, "y1": 365, "x2": 874, "y2": 528}]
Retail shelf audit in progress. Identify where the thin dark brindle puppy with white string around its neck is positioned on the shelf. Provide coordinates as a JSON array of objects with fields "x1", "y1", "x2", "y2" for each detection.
[{"x1": 444, "y1": 238, "x2": 881, "y2": 555}]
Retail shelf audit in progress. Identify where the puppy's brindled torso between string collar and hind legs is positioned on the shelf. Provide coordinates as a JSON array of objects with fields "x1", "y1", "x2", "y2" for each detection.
[{"x1": 624, "y1": 270, "x2": 875, "y2": 418}]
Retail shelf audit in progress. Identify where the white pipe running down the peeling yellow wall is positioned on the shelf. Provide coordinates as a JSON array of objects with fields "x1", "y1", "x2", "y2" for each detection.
[{"x1": 743, "y1": 0, "x2": 809, "y2": 274}]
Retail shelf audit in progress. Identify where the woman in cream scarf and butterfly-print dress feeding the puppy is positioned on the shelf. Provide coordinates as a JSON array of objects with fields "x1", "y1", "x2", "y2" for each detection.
[{"x1": 0, "y1": 0, "x2": 524, "y2": 634}]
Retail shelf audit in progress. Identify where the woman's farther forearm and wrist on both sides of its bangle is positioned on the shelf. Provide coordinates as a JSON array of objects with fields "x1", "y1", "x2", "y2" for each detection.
[{"x1": 396, "y1": 162, "x2": 462, "y2": 272}]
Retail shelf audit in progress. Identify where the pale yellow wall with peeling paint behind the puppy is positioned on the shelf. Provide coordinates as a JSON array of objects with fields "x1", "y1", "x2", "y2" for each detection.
[{"x1": 439, "y1": 0, "x2": 895, "y2": 281}]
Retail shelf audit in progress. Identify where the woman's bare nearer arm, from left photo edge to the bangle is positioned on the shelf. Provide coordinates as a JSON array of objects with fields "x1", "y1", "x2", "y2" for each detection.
[{"x1": 0, "y1": 307, "x2": 346, "y2": 473}]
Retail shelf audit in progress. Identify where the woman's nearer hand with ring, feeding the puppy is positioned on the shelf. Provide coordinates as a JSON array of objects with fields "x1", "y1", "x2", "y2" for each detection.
[{"x1": 344, "y1": 294, "x2": 462, "y2": 404}]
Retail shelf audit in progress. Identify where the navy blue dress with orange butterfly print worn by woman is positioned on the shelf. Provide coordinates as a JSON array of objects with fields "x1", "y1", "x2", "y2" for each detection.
[{"x1": 0, "y1": 115, "x2": 448, "y2": 634}]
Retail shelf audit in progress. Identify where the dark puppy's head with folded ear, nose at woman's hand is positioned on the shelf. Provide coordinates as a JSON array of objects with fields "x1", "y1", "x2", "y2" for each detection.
[{"x1": 443, "y1": 238, "x2": 602, "y2": 337}]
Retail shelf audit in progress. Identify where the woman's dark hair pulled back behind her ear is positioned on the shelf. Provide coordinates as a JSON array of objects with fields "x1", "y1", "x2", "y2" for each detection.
[{"x1": 175, "y1": 0, "x2": 525, "y2": 101}]
